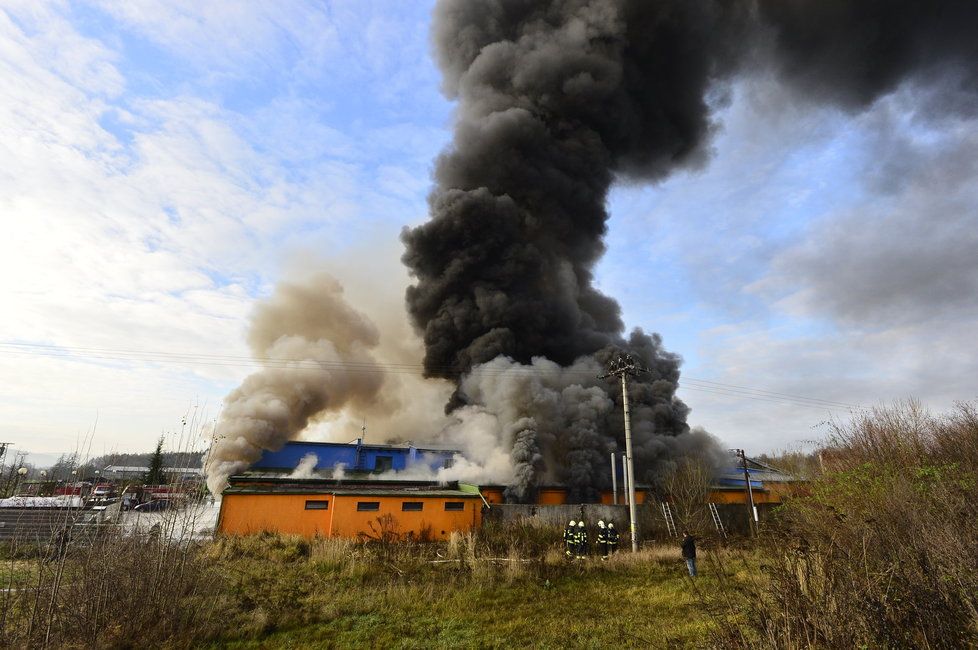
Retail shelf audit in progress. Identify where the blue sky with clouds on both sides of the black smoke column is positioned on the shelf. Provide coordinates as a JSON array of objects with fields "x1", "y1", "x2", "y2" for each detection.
[{"x1": 0, "y1": 0, "x2": 978, "y2": 460}]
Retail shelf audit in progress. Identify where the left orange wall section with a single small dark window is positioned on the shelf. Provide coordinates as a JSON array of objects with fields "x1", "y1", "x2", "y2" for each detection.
[{"x1": 218, "y1": 494, "x2": 333, "y2": 537}]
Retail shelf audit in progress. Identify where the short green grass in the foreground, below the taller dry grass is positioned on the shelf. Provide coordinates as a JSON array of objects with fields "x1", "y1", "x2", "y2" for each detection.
[{"x1": 198, "y1": 554, "x2": 740, "y2": 649}]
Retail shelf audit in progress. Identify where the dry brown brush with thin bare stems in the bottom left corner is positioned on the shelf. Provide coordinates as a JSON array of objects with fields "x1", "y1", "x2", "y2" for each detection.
[{"x1": 0, "y1": 526, "x2": 221, "y2": 648}]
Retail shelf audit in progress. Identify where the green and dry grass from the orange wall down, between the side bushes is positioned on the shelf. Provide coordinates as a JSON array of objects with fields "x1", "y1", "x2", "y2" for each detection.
[{"x1": 200, "y1": 535, "x2": 740, "y2": 648}]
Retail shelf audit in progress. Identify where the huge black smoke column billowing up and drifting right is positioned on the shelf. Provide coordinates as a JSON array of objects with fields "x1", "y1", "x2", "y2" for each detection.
[{"x1": 403, "y1": 0, "x2": 978, "y2": 498}]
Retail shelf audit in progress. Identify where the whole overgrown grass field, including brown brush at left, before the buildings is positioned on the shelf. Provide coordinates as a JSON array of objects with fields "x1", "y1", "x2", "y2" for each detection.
[{"x1": 0, "y1": 527, "x2": 756, "y2": 648}]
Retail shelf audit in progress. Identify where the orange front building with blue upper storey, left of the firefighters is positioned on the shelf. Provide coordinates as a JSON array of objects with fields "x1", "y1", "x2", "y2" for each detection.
[{"x1": 217, "y1": 438, "x2": 486, "y2": 539}]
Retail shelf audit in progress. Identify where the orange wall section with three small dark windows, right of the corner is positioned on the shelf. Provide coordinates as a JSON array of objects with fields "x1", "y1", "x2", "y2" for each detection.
[{"x1": 330, "y1": 495, "x2": 482, "y2": 539}]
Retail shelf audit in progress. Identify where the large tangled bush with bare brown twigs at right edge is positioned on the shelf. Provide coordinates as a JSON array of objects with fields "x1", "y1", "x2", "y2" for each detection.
[{"x1": 728, "y1": 402, "x2": 978, "y2": 648}]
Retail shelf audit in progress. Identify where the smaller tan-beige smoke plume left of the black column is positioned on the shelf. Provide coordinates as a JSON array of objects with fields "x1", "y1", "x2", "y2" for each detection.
[{"x1": 205, "y1": 274, "x2": 384, "y2": 494}]
